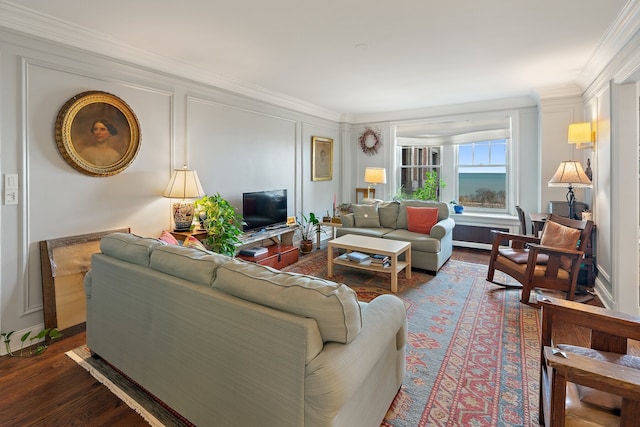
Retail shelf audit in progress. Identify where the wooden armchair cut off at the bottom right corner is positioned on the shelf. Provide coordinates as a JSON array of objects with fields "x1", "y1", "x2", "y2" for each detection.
[{"x1": 538, "y1": 296, "x2": 640, "y2": 427}]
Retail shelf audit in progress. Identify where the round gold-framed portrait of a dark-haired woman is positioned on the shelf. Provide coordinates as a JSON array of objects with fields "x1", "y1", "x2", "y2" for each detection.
[{"x1": 55, "y1": 91, "x2": 140, "y2": 176}]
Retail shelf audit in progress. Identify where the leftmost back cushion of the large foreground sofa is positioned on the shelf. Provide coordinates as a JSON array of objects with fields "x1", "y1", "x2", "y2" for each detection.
[{"x1": 100, "y1": 233, "x2": 165, "y2": 267}]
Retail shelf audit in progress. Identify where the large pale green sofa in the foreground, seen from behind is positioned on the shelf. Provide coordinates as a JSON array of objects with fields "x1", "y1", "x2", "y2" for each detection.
[{"x1": 84, "y1": 233, "x2": 407, "y2": 427}]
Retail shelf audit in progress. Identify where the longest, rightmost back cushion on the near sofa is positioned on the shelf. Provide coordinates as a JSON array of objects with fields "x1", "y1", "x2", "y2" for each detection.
[{"x1": 213, "y1": 262, "x2": 362, "y2": 344}]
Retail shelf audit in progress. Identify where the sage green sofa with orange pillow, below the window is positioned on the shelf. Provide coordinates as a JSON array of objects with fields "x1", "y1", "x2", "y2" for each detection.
[{"x1": 336, "y1": 200, "x2": 455, "y2": 273}]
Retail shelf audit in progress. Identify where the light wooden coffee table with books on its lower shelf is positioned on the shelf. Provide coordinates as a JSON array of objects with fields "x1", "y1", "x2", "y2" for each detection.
[{"x1": 327, "y1": 234, "x2": 411, "y2": 292}]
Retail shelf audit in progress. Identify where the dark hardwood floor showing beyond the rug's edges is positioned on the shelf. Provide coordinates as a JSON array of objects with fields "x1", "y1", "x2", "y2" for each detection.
[{"x1": 0, "y1": 248, "x2": 604, "y2": 426}]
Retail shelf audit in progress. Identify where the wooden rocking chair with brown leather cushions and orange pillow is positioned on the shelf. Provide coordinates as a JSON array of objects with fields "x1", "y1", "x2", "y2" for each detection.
[{"x1": 487, "y1": 214, "x2": 593, "y2": 305}]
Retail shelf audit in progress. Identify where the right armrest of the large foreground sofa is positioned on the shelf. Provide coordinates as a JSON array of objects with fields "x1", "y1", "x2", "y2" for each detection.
[{"x1": 305, "y1": 295, "x2": 407, "y2": 419}]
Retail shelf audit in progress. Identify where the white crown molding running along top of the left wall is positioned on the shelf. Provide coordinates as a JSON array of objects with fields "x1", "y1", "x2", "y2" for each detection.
[{"x1": 0, "y1": 0, "x2": 341, "y2": 122}]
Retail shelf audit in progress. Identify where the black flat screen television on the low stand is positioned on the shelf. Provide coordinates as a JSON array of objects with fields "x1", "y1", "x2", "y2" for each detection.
[{"x1": 242, "y1": 190, "x2": 287, "y2": 231}]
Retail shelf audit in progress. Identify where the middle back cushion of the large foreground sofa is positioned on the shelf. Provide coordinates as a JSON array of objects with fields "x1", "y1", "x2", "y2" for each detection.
[{"x1": 150, "y1": 245, "x2": 233, "y2": 285}]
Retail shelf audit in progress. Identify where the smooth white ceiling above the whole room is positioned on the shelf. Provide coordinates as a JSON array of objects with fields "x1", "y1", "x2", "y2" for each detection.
[{"x1": 0, "y1": 0, "x2": 636, "y2": 115}]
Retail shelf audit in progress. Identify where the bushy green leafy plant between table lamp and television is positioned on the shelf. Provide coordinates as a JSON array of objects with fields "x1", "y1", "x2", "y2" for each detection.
[{"x1": 195, "y1": 193, "x2": 242, "y2": 256}]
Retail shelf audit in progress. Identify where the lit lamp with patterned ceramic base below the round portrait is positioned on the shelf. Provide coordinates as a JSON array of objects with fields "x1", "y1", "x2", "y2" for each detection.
[{"x1": 162, "y1": 166, "x2": 205, "y2": 231}]
